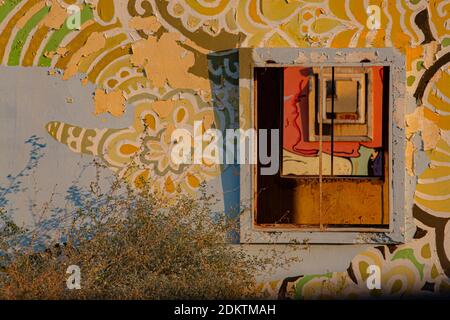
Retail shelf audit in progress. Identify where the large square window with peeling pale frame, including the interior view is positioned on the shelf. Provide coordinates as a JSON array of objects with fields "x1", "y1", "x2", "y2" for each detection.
[{"x1": 241, "y1": 49, "x2": 405, "y2": 243}]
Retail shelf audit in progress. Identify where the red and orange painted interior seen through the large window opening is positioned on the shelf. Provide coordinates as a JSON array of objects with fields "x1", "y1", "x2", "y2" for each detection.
[{"x1": 255, "y1": 65, "x2": 389, "y2": 230}]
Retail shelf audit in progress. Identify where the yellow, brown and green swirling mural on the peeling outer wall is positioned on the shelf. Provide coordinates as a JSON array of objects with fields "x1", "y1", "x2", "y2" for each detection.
[{"x1": 0, "y1": 0, "x2": 450, "y2": 298}]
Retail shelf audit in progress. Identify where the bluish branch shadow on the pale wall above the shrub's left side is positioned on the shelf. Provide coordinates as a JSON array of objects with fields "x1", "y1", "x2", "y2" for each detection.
[{"x1": 0, "y1": 135, "x2": 111, "y2": 251}]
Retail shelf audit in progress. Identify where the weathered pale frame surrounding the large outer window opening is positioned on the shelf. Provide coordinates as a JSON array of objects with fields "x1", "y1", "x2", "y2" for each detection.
[{"x1": 239, "y1": 48, "x2": 414, "y2": 244}]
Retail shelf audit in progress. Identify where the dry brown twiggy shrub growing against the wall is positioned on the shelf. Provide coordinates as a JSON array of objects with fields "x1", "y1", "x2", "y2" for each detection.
[{"x1": 0, "y1": 162, "x2": 268, "y2": 299}]
